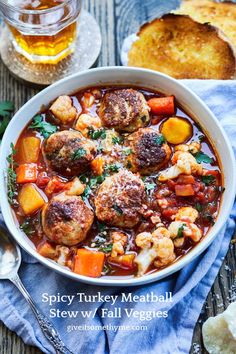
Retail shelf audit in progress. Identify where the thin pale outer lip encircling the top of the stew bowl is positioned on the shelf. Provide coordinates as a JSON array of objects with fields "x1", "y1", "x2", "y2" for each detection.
[{"x1": 0, "y1": 66, "x2": 236, "y2": 286}]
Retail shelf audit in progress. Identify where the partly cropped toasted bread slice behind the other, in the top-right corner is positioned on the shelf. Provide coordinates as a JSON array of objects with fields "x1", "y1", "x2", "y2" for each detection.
[{"x1": 174, "y1": 0, "x2": 236, "y2": 47}]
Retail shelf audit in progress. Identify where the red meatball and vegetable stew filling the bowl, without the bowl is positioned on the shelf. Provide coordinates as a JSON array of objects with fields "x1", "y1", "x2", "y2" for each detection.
[{"x1": 8, "y1": 87, "x2": 223, "y2": 277}]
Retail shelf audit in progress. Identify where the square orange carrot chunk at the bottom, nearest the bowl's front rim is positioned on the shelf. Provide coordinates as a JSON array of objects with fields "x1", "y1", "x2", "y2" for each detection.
[{"x1": 73, "y1": 248, "x2": 105, "y2": 278}]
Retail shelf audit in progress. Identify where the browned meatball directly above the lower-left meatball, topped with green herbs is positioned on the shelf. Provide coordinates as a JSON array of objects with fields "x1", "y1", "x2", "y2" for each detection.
[{"x1": 44, "y1": 130, "x2": 96, "y2": 176}]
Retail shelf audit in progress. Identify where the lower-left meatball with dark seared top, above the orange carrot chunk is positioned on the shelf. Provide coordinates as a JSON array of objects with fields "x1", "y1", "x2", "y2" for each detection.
[{"x1": 42, "y1": 193, "x2": 94, "y2": 246}]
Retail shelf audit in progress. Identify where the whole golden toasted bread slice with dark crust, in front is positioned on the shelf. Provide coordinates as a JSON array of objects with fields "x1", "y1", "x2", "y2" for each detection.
[{"x1": 128, "y1": 14, "x2": 236, "y2": 79}]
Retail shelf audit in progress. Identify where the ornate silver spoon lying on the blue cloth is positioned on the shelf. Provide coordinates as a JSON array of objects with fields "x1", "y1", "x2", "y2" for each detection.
[{"x1": 0, "y1": 226, "x2": 73, "y2": 354}]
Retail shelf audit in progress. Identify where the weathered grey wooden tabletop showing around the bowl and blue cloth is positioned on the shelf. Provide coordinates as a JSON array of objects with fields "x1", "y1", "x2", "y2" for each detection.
[{"x1": 0, "y1": 0, "x2": 236, "y2": 354}]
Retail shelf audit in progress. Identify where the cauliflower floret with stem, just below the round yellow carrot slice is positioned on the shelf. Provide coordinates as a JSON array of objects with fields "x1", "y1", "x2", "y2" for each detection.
[{"x1": 158, "y1": 151, "x2": 202, "y2": 182}]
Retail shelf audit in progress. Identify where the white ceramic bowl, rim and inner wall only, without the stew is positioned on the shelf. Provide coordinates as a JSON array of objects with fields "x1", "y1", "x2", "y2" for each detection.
[{"x1": 0, "y1": 67, "x2": 236, "y2": 286}]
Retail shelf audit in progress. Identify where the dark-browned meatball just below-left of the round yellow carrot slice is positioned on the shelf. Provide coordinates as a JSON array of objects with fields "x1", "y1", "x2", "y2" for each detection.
[{"x1": 125, "y1": 128, "x2": 171, "y2": 175}]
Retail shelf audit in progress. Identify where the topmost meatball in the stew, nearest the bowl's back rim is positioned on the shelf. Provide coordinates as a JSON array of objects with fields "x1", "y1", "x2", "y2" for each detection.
[{"x1": 99, "y1": 89, "x2": 150, "y2": 132}]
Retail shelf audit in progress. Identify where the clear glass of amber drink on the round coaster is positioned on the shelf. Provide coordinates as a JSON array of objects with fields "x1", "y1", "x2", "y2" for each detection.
[{"x1": 0, "y1": 0, "x2": 82, "y2": 64}]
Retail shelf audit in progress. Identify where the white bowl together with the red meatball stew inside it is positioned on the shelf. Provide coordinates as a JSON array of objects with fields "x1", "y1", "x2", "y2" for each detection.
[{"x1": 0, "y1": 67, "x2": 236, "y2": 285}]
